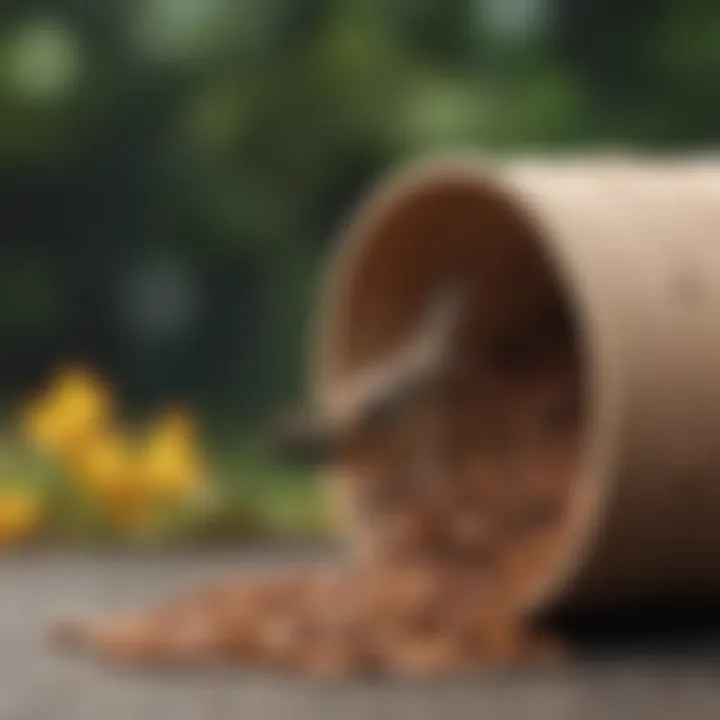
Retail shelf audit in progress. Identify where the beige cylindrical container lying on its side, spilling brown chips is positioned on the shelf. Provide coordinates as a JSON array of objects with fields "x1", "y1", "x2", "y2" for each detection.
[{"x1": 313, "y1": 156, "x2": 720, "y2": 611}]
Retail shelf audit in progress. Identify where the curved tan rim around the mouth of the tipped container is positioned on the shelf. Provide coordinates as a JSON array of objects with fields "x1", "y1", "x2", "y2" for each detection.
[{"x1": 309, "y1": 153, "x2": 624, "y2": 615}]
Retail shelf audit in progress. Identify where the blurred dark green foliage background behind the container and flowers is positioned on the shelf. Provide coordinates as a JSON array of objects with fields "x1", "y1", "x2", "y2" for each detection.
[{"x1": 0, "y1": 0, "x2": 720, "y2": 534}]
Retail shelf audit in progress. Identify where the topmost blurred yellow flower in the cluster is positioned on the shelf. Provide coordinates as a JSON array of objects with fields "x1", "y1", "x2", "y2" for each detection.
[{"x1": 24, "y1": 367, "x2": 112, "y2": 454}]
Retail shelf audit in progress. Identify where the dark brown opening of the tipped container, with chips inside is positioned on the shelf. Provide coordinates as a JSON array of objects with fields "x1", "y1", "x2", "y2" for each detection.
[{"x1": 324, "y1": 176, "x2": 584, "y2": 602}]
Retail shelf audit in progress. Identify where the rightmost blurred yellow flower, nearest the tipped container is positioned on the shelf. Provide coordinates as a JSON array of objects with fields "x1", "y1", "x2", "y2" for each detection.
[{"x1": 141, "y1": 411, "x2": 202, "y2": 499}]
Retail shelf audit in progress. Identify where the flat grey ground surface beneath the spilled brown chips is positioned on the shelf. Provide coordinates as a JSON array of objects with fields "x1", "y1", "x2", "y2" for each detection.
[{"x1": 0, "y1": 551, "x2": 720, "y2": 720}]
